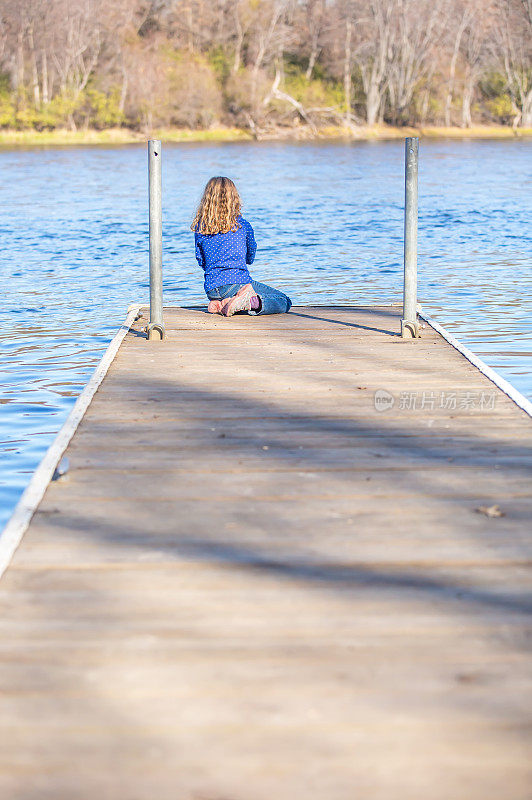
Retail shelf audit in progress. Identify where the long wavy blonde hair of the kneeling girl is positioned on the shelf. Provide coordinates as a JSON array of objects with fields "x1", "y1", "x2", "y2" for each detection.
[{"x1": 190, "y1": 177, "x2": 242, "y2": 233}]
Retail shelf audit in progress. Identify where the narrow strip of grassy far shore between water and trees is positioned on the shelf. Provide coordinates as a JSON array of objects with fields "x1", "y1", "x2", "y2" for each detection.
[{"x1": 0, "y1": 125, "x2": 532, "y2": 148}]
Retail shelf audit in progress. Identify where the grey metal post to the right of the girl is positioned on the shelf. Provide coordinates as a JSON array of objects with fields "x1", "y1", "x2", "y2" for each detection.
[{"x1": 401, "y1": 136, "x2": 419, "y2": 339}]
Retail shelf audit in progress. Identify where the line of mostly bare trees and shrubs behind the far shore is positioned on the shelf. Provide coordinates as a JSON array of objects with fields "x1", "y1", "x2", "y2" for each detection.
[{"x1": 0, "y1": 0, "x2": 532, "y2": 134}]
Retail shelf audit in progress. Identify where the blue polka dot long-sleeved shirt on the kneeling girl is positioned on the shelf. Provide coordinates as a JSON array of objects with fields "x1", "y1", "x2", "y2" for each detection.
[{"x1": 194, "y1": 217, "x2": 257, "y2": 292}]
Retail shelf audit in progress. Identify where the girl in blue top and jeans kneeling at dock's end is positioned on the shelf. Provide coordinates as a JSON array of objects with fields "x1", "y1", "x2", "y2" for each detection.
[{"x1": 191, "y1": 177, "x2": 292, "y2": 317}]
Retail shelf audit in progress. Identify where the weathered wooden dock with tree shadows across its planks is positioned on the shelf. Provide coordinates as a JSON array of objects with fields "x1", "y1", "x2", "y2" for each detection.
[{"x1": 0, "y1": 307, "x2": 532, "y2": 800}]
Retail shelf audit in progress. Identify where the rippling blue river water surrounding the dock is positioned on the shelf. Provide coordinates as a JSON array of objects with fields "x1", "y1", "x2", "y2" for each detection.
[{"x1": 0, "y1": 140, "x2": 532, "y2": 528}]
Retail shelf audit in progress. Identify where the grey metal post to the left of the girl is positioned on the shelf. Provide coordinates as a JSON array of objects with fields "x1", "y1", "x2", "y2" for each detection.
[{"x1": 147, "y1": 139, "x2": 164, "y2": 341}]
